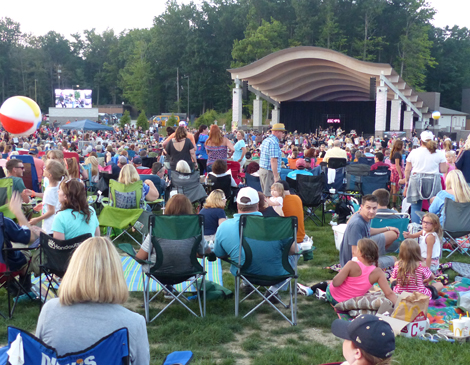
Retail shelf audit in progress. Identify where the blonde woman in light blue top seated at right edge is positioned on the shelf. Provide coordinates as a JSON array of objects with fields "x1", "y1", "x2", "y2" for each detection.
[{"x1": 429, "y1": 170, "x2": 470, "y2": 225}]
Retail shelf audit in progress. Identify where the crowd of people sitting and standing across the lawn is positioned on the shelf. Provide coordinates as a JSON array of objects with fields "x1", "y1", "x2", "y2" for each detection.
[{"x1": 0, "y1": 122, "x2": 470, "y2": 364}]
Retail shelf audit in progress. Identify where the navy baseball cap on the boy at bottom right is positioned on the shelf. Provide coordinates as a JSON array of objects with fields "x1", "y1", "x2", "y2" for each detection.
[{"x1": 331, "y1": 314, "x2": 395, "y2": 359}]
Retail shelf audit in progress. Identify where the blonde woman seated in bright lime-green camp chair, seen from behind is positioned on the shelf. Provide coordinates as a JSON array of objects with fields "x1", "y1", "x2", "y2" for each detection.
[{"x1": 116, "y1": 164, "x2": 159, "y2": 209}]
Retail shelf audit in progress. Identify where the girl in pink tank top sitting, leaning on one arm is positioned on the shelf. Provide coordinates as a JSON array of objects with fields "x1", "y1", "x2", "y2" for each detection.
[{"x1": 297, "y1": 238, "x2": 397, "y2": 305}]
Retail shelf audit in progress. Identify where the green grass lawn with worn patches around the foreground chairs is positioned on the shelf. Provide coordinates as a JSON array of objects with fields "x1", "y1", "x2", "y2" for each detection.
[{"x1": 0, "y1": 209, "x2": 470, "y2": 365}]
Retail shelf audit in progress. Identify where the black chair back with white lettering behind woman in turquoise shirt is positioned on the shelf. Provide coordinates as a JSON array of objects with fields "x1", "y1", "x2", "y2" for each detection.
[{"x1": 40, "y1": 232, "x2": 91, "y2": 277}]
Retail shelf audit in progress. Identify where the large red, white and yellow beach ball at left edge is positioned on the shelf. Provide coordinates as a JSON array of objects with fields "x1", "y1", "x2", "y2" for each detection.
[{"x1": 0, "y1": 96, "x2": 42, "y2": 136}]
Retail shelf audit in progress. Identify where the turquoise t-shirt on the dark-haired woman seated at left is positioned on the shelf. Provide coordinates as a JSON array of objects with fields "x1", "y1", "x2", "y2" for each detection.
[{"x1": 52, "y1": 207, "x2": 100, "y2": 240}]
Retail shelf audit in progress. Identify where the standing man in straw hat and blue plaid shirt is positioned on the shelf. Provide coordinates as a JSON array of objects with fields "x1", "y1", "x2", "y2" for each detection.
[{"x1": 259, "y1": 123, "x2": 286, "y2": 196}]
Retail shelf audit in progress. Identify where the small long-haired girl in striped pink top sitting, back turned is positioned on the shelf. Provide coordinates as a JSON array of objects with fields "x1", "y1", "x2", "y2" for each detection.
[{"x1": 391, "y1": 239, "x2": 444, "y2": 299}]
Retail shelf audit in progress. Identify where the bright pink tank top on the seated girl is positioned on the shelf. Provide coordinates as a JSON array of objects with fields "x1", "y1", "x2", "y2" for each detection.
[{"x1": 329, "y1": 260, "x2": 375, "y2": 302}]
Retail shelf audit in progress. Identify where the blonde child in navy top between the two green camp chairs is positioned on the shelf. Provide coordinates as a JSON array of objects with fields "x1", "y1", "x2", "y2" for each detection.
[{"x1": 199, "y1": 189, "x2": 227, "y2": 242}]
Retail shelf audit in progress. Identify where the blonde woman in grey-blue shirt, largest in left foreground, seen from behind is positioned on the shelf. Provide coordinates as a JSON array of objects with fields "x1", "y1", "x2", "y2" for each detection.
[{"x1": 36, "y1": 237, "x2": 150, "y2": 364}]
